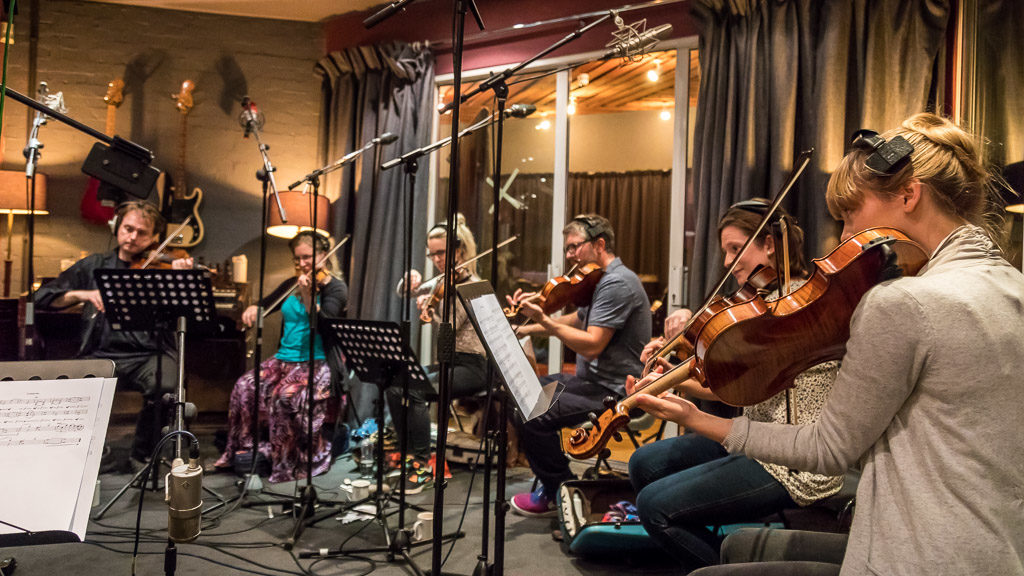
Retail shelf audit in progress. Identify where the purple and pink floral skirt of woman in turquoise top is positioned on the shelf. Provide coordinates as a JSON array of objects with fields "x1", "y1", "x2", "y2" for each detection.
[{"x1": 214, "y1": 358, "x2": 339, "y2": 483}]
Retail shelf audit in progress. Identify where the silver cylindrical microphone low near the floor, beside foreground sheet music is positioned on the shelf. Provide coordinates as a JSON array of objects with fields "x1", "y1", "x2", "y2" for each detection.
[{"x1": 164, "y1": 442, "x2": 203, "y2": 542}]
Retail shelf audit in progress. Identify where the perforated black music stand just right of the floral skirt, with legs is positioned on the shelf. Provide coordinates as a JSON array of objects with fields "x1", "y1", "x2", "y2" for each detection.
[{"x1": 300, "y1": 318, "x2": 463, "y2": 574}]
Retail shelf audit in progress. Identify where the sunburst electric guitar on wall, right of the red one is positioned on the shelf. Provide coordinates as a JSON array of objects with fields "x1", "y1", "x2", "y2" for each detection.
[{"x1": 157, "y1": 80, "x2": 204, "y2": 248}]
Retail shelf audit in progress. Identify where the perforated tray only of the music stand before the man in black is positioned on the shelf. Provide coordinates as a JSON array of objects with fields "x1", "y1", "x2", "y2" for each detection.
[{"x1": 93, "y1": 269, "x2": 217, "y2": 331}]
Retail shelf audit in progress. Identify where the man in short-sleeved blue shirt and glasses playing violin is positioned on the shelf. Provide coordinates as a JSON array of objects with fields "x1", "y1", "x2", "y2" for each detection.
[{"x1": 511, "y1": 214, "x2": 651, "y2": 516}]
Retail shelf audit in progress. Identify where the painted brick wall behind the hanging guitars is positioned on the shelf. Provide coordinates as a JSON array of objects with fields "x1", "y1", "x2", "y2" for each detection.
[{"x1": 2, "y1": 0, "x2": 323, "y2": 291}]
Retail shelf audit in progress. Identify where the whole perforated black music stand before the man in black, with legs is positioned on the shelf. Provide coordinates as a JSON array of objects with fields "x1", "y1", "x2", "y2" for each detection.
[{"x1": 92, "y1": 269, "x2": 224, "y2": 520}]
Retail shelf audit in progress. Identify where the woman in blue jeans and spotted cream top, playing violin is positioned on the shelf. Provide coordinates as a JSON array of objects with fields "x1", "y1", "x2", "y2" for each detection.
[{"x1": 630, "y1": 199, "x2": 843, "y2": 570}]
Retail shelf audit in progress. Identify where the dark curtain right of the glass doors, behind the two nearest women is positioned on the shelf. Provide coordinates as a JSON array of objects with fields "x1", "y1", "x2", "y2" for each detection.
[{"x1": 689, "y1": 0, "x2": 949, "y2": 306}]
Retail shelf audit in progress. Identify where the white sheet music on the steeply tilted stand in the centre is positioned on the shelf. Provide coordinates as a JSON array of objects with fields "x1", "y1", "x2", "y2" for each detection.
[{"x1": 469, "y1": 294, "x2": 546, "y2": 417}]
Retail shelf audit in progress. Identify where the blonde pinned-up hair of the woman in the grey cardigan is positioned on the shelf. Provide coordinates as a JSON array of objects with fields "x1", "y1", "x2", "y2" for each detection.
[{"x1": 825, "y1": 113, "x2": 996, "y2": 239}]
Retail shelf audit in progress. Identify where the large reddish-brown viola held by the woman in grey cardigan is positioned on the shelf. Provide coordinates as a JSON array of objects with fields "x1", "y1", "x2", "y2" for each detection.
[{"x1": 566, "y1": 228, "x2": 928, "y2": 459}]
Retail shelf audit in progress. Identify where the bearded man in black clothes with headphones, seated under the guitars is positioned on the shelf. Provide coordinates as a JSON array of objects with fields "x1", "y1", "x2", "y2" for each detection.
[{"x1": 36, "y1": 201, "x2": 193, "y2": 461}]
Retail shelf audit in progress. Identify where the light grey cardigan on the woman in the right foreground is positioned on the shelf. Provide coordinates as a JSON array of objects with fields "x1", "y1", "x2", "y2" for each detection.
[{"x1": 723, "y1": 227, "x2": 1024, "y2": 576}]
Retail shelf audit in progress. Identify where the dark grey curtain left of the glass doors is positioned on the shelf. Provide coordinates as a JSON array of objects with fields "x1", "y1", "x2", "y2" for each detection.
[{"x1": 316, "y1": 43, "x2": 434, "y2": 320}]
